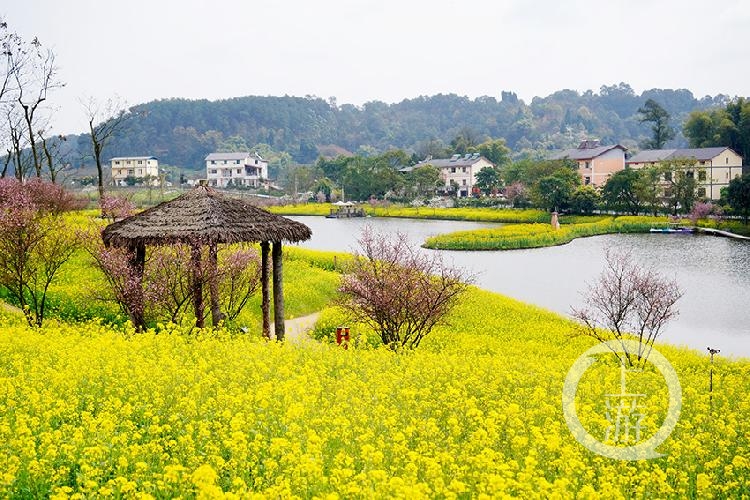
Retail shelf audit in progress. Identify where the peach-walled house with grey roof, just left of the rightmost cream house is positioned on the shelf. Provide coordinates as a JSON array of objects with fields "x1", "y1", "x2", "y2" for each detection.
[{"x1": 549, "y1": 141, "x2": 627, "y2": 187}]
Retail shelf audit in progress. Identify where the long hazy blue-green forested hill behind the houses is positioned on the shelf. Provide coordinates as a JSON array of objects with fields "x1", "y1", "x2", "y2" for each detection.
[{"x1": 73, "y1": 83, "x2": 729, "y2": 168}]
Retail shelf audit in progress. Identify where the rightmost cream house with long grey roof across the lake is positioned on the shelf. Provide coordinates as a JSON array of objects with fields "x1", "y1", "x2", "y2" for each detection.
[{"x1": 627, "y1": 147, "x2": 742, "y2": 200}]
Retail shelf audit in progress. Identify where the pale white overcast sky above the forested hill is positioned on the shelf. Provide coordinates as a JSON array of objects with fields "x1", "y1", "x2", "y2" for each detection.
[{"x1": 0, "y1": 0, "x2": 750, "y2": 133}]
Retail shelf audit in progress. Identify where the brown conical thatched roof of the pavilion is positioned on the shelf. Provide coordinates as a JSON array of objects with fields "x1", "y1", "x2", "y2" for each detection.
[{"x1": 102, "y1": 186, "x2": 312, "y2": 246}]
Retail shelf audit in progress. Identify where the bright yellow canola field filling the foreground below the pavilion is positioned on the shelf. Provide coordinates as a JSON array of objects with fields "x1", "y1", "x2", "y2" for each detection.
[{"x1": 0, "y1": 278, "x2": 750, "y2": 498}]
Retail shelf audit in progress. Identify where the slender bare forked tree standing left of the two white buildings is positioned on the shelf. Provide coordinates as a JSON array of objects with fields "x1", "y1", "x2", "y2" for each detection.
[{"x1": 82, "y1": 98, "x2": 132, "y2": 199}]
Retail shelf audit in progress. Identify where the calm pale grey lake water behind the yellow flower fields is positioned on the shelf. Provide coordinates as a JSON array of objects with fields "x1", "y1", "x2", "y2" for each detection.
[{"x1": 291, "y1": 217, "x2": 750, "y2": 357}]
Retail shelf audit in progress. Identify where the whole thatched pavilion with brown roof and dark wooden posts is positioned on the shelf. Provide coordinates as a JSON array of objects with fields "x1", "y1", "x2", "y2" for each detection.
[{"x1": 102, "y1": 186, "x2": 312, "y2": 339}]
